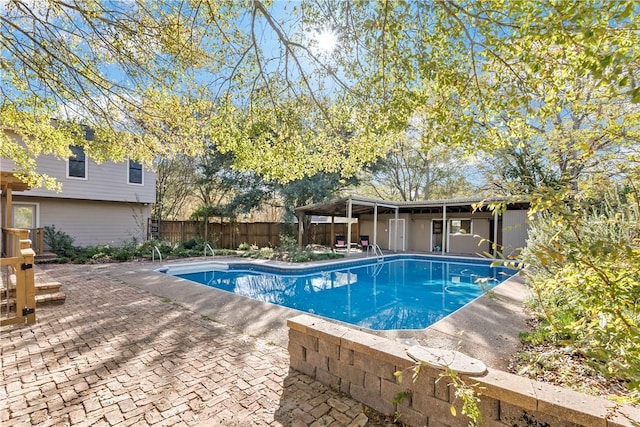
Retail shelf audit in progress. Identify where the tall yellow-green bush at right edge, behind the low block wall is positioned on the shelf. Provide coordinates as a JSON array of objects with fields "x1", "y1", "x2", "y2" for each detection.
[{"x1": 523, "y1": 191, "x2": 640, "y2": 391}]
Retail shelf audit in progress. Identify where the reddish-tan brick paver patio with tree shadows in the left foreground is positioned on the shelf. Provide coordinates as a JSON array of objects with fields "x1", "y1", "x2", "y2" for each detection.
[{"x1": 0, "y1": 265, "x2": 373, "y2": 426}]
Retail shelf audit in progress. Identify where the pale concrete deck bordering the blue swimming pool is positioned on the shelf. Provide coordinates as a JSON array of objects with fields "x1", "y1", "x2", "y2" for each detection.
[{"x1": 92, "y1": 256, "x2": 529, "y2": 370}]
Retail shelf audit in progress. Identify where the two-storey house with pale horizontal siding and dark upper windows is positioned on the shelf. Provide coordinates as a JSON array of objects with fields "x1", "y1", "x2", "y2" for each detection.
[{"x1": 1, "y1": 132, "x2": 156, "y2": 246}]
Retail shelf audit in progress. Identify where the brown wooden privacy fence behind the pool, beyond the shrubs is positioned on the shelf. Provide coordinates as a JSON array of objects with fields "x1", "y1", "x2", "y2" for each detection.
[{"x1": 148, "y1": 219, "x2": 359, "y2": 249}]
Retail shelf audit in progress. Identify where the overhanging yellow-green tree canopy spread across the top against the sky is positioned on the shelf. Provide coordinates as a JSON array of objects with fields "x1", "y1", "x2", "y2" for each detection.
[{"x1": 0, "y1": 0, "x2": 640, "y2": 189}]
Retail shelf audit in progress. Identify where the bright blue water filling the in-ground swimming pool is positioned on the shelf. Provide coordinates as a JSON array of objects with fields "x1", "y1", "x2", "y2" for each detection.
[{"x1": 172, "y1": 257, "x2": 514, "y2": 330}]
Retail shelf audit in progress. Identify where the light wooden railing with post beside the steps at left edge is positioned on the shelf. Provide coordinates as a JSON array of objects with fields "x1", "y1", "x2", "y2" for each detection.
[{"x1": 0, "y1": 230, "x2": 36, "y2": 326}]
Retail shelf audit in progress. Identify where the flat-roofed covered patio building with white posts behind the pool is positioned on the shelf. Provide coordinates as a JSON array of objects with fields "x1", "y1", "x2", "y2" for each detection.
[{"x1": 295, "y1": 195, "x2": 529, "y2": 257}]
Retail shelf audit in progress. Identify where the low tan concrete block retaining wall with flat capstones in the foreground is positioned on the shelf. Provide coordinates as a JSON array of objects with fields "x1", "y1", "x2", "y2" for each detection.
[{"x1": 288, "y1": 315, "x2": 640, "y2": 427}]
